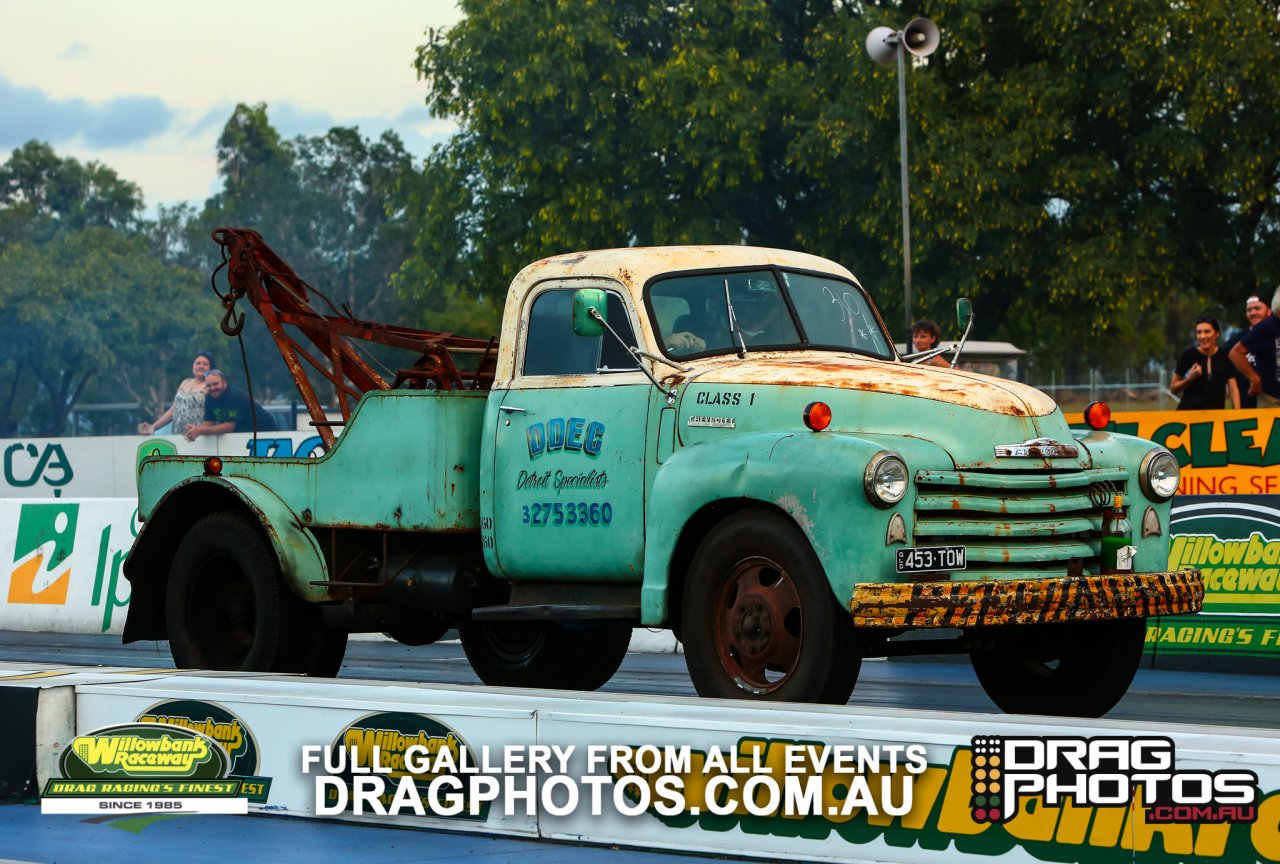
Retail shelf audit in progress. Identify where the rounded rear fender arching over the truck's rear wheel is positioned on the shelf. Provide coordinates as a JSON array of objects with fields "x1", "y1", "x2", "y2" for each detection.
[{"x1": 124, "y1": 476, "x2": 328, "y2": 643}]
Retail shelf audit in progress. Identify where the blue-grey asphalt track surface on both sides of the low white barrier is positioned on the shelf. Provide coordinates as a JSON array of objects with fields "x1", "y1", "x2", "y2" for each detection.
[{"x1": 0, "y1": 631, "x2": 1280, "y2": 864}]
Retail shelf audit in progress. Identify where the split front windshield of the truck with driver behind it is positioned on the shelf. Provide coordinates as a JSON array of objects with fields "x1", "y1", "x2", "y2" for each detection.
[{"x1": 649, "y1": 270, "x2": 893, "y2": 360}]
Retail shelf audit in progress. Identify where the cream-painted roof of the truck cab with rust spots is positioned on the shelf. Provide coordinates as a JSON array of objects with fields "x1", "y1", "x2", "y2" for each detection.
[{"x1": 512, "y1": 246, "x2": 856, "y2": 288}]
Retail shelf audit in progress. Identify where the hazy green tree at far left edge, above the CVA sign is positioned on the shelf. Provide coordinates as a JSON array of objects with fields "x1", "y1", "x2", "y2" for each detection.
[{"x1": 0, "y1": 142, "x2": 209, "y2": 435}]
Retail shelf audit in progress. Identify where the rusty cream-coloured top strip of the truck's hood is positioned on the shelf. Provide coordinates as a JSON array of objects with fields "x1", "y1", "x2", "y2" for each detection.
[{"x1": 698, "y1": 352, "x2": 1057, "y2": 417}]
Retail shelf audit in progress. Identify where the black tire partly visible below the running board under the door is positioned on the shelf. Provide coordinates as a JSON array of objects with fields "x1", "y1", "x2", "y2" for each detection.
[{"x1": 458, "y1": 621, "x2": 631, "y2": 690}]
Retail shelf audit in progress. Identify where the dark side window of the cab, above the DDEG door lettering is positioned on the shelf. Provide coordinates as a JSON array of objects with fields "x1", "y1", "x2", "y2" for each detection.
[{"x1": 524, "y1": 288, "x2": 636, "y2": 375}]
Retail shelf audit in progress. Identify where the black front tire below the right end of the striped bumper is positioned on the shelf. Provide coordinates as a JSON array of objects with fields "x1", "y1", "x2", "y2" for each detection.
[{"x1": 969, "y1": 618, "x2": 1147, "y2": 717}]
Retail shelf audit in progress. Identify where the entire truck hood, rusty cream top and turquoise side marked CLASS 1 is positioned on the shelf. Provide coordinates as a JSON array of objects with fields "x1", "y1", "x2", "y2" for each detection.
[{"x1": 677, "y1": 352, "x2": 1092, "y2": 471}]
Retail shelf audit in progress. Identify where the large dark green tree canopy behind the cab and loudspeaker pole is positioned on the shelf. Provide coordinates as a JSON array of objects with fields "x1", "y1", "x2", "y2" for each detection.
[{"x1": 398, "y1": 0, "x2": 1280, "y2": 364}]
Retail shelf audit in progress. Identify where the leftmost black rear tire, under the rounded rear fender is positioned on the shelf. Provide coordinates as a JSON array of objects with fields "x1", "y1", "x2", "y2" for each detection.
[{"x1": 165, "y1": 511, "x2": 292, "y2": 672}]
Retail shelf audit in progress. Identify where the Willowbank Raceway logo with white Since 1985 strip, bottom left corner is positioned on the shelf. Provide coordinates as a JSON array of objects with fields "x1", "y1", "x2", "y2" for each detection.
[{"x1": 40, "y1": 723, "x2": 248, "y2": 814}]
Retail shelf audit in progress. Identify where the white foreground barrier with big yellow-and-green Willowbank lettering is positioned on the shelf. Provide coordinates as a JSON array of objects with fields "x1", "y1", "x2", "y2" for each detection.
[{"x1": 49, "y1": 676, "x2": 1280, "y2": 864}]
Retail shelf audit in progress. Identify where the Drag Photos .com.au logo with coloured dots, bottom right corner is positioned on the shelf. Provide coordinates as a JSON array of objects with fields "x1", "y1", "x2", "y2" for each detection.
[{"x1": 970, "y1": 736, "x2": 1258, "y2": 824}]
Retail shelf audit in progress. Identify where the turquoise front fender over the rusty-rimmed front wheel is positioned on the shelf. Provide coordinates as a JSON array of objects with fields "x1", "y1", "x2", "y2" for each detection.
[{"x1": 640, "y1": 433, "x2": 951, "y2": 625}]
